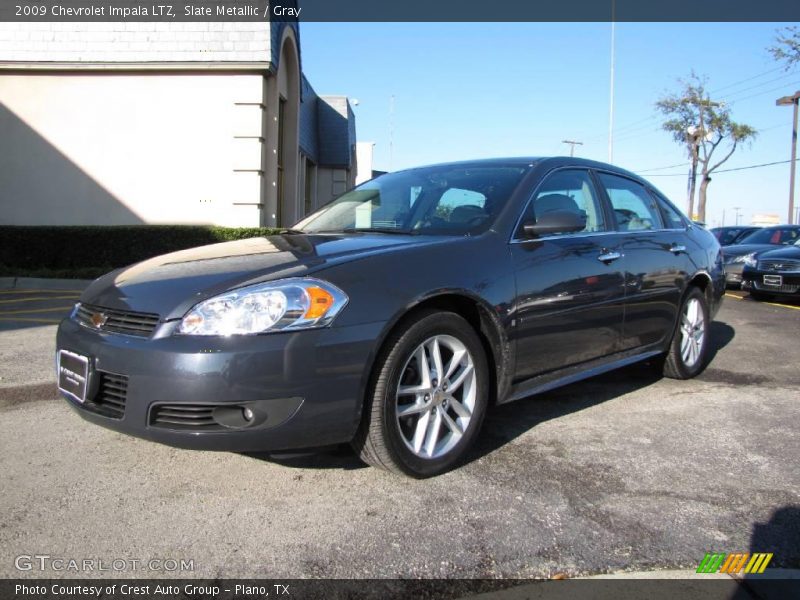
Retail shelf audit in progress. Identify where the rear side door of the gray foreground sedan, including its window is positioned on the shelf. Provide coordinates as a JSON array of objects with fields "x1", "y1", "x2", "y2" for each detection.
[{"x1": 597, "y1": 172, "x2": 689, "y2": 350}]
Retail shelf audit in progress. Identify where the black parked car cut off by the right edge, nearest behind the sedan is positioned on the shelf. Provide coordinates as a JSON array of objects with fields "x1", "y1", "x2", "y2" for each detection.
[{"x1": 742, "y1": 238, "x2": 800, "y2": 300}]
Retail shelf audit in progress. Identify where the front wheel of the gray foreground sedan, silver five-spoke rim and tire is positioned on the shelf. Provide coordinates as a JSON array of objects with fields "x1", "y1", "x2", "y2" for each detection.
[{"x1": 352, "y1": 310, "x2": 489, "y2": 478}]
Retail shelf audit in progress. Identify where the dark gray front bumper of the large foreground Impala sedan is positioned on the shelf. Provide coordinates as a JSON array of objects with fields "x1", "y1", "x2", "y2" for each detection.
[{"x1": 56, "y1": 319, "x2": 383, "y2": 452}]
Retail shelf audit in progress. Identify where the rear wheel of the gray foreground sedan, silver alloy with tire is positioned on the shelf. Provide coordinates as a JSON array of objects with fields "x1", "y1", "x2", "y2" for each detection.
[{"x1": 664, "y1": 287, "x2": 711, "y2": 379}]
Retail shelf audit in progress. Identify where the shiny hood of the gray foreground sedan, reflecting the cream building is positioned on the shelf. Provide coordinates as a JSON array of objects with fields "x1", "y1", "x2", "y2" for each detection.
[{"x1": 81, "y1": 234, "x2": 447, "y2": 320}]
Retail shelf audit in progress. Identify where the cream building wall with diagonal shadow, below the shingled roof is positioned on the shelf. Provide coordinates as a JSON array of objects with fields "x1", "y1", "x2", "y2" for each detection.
[{"x1": 0, "y1": 72, "x2": 264, "y2": 226}]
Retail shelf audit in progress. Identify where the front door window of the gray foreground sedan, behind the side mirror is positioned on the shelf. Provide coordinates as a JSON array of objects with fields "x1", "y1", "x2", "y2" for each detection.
[{"x1": 515, "y1": 169, "x2": 605, "y2": 239}]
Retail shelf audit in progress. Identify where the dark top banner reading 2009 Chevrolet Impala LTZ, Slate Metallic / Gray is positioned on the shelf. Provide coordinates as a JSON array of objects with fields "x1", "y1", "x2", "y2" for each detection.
[{"x1": 0, "y1": 0, "x2": 800, "y2": 22}]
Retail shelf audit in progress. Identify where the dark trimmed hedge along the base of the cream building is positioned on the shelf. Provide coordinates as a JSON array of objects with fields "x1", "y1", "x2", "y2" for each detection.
[{"x1": 0, "y1": 225, "x2": 279, "y2": 279}]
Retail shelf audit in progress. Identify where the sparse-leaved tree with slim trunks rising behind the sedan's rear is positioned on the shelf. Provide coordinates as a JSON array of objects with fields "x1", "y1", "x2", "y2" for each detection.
[{"x1": 656, "y1": 72, "x2": 757, "y2": 221}]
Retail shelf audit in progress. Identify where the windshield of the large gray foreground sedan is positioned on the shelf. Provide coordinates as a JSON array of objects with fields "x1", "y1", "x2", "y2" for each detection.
[{"x1": 293, "y1": 165, "x2": 529, "y2": 235}]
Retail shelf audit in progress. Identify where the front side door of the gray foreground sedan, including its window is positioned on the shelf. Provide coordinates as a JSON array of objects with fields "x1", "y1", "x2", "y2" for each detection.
[{"x1": 511, "y1": 168, "x2": 625, "y2": 381}]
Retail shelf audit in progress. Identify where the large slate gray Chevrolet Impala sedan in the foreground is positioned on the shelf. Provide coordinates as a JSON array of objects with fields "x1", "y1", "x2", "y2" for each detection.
[{"x1": 57, "y1": 158, "x2": 724, "y2": 477}]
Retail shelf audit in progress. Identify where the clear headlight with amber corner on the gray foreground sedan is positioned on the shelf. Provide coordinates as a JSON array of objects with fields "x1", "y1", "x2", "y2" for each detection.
[{"x1": 178, "y1": 278, "x2": 348, "y2": 335}]
